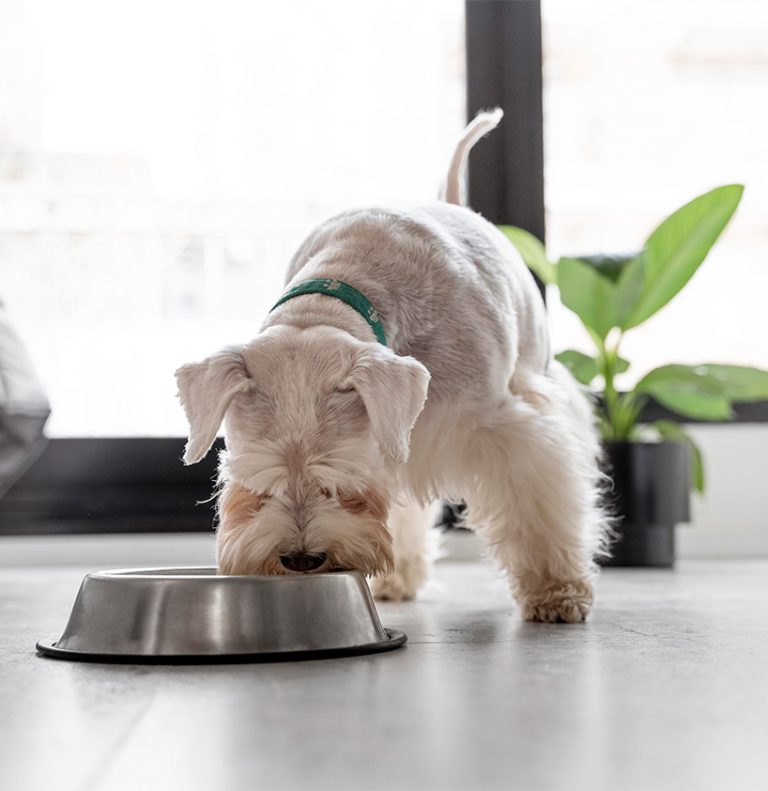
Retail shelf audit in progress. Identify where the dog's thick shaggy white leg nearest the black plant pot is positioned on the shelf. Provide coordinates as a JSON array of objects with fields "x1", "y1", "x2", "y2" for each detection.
[{"x1": 465, "y1": 372, "x2": 607, "y2": 623}]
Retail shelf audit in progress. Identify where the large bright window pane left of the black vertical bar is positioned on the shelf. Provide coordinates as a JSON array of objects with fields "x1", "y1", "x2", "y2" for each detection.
[{"x1": 0, "y1": 0, "x2": 465, "y2": 437}]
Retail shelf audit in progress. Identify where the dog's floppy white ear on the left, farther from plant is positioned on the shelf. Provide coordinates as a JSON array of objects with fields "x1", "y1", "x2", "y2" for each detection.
[{"x1": 176, "y1": 348, "x2": 254, "y2": 464}]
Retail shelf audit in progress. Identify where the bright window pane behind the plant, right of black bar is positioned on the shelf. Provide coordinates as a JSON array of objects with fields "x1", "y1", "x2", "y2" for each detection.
[{"x1": 542, "y1": 0, "x2": 768, "y2": 383}]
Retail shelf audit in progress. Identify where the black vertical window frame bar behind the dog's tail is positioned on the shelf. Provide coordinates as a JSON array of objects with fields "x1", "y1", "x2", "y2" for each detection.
[{"x1": 465, "y1": 0, "x2": 545, "y2": 241}]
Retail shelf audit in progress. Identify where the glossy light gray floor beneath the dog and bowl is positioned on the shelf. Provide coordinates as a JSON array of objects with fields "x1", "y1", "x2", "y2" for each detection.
[{"x1": 0, "y1": 561, "x2": 768, "y2": 791}]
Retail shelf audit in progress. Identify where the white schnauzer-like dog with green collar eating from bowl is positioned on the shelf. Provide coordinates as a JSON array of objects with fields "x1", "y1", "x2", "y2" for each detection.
[{"x1": 176, "y1": 110, "x2": 606, "y2": 622}]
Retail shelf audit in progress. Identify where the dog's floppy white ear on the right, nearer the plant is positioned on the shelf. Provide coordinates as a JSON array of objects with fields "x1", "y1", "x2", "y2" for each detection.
[{"x1": 342, "y1": 344, "x2": 429, "y2": 464}]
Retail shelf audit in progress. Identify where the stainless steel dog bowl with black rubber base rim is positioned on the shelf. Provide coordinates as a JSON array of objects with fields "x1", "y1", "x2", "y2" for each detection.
[{"x1": 37, "y1": 568, "x2": 407, "y2": 663}]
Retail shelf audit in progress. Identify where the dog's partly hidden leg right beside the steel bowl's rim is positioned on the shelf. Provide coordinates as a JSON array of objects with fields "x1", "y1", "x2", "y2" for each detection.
[{"x1": 371, "y1": 503, "x2": 440, "y2": 601}]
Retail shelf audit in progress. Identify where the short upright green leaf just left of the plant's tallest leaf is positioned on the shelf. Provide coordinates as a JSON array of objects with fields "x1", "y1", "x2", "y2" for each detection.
[{"x1": 557, "y1": 258, "x2": 617, "y2": 340}]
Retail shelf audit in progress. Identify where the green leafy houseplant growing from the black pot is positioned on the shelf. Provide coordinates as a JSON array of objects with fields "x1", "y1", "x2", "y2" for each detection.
[{"x1": 500, "y1": 184, "x2": 768, "y2": 491}]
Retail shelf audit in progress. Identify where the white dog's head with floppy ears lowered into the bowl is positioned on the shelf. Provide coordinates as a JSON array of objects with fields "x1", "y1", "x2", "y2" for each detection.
[{"x1": 176, "y1": 327, "x2": 429, "y2": 574}]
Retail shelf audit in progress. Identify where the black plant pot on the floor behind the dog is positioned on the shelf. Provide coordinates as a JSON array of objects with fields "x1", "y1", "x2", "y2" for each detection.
[{"x1": 601, "y1": 442, "x2": 691, "y2": 568}]
